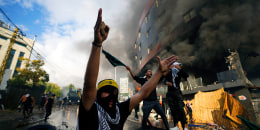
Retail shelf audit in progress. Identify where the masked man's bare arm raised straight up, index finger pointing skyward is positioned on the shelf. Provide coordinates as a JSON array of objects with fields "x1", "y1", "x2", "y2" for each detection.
[{"x1": 82, "y1": 9, "x2": 109, "y2": 111}]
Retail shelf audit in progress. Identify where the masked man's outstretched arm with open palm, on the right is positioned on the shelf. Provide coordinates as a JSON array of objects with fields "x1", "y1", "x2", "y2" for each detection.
[{"x1": 129, "y1": 55, "x2": 178, "y2": 111}]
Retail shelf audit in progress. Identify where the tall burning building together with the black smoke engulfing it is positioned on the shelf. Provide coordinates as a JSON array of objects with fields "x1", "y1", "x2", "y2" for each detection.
[{"x1": 132, "y1": 0, "x2": 260, "y2": 86}]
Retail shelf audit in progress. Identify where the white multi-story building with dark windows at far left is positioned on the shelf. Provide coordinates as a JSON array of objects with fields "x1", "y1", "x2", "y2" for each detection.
[{"x1": 0, "y1": 21, "x2": 35, "y2": 90}]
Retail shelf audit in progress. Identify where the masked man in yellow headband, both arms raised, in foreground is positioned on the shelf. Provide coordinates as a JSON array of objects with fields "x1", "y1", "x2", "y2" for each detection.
[{"x1": 77, "y1": 9, "x2": 177, "y2": 130}]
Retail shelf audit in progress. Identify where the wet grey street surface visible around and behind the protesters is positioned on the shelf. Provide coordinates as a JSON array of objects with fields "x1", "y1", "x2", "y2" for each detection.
[{"x1": 0, "y1": 105, "x2": 250, "y2": 130}]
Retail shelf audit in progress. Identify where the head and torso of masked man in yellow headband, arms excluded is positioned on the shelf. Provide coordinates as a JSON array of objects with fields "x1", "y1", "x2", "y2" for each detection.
[{"x1": 77, "y1": 79, "x2": 130, "y2": 130}]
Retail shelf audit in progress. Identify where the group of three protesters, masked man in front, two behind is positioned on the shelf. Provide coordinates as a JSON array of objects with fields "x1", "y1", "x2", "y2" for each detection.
[{"x1": 77, "y1": 9, "x2": 192, "y2": 130}]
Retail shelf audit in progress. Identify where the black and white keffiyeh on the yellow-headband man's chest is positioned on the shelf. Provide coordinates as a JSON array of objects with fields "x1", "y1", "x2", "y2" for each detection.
[{"x1": 95, "y1": 102, "x2": 120, "y2": 130}]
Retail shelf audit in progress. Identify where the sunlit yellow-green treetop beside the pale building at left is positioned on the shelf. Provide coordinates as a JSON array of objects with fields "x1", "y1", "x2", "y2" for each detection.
[{"x1": 16, "y1": 58, "x2": 49, "y2": 86}]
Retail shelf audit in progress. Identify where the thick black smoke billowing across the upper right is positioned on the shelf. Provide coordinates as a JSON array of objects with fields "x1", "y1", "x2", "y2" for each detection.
[{"x1": 157, "y1": 0, "x2": 260, "y2": 83}]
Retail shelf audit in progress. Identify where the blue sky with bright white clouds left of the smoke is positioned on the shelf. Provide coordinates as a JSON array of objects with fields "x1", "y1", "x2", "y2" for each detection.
[{"x1": 0, "y1": 0, "x2": 148, "y2": 88}]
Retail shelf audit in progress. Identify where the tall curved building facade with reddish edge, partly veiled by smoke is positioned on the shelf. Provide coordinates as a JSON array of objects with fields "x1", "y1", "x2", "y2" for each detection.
[{"x1": 134, "y1": 0, "x2": 203, "y2": 73}]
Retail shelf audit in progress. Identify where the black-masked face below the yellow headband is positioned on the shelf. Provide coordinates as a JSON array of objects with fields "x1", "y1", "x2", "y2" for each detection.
[{"x1": 97, "y1": 87, "x2": 118, "y2": 112}]
